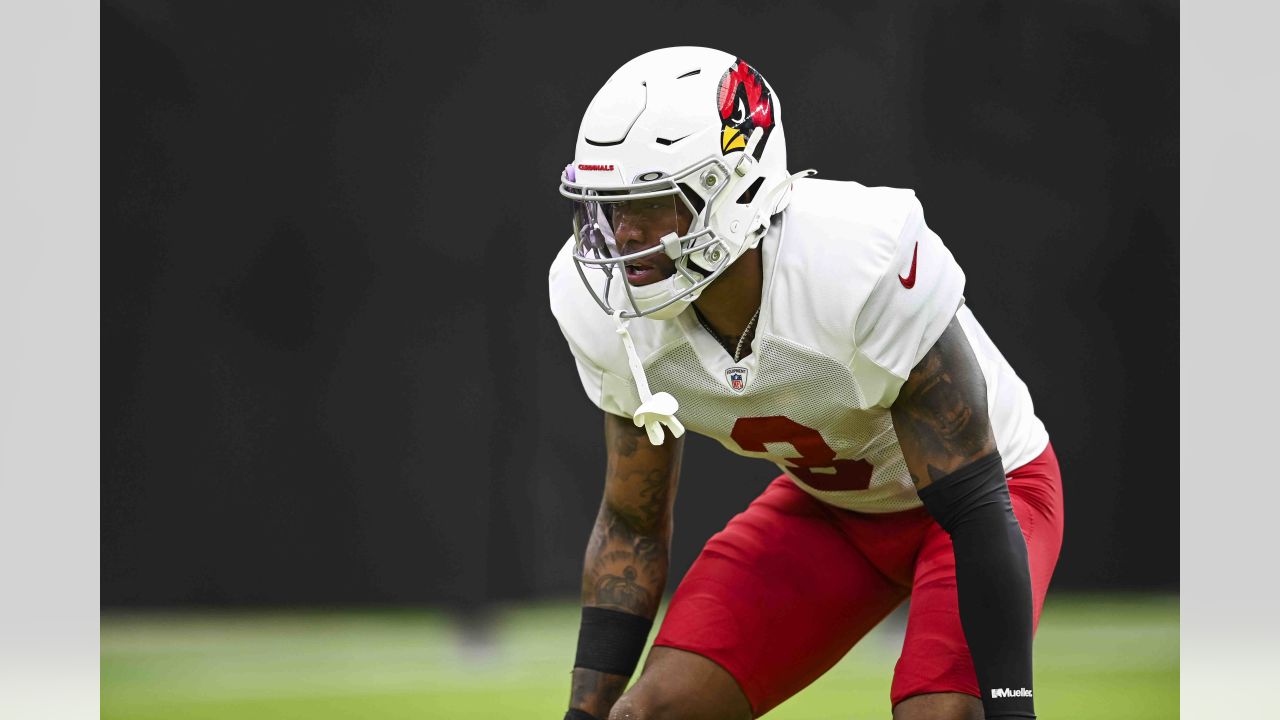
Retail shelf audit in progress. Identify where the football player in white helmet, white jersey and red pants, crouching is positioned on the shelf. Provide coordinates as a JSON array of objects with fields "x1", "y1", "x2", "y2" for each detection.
[{"x1": 549, "y1": 47, "x2": 1062, "y2": 720}]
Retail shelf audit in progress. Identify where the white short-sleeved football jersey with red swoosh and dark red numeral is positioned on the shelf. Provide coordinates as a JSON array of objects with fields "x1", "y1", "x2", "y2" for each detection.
[{"x1": 550, "y1": 179, "x2": 1048, "y2": 512}]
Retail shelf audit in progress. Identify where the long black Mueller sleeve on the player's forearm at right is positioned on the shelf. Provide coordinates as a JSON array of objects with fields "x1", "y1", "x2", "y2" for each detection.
[{"x1": 919, "y1": 452, "x2": 1036, "y2": 720}]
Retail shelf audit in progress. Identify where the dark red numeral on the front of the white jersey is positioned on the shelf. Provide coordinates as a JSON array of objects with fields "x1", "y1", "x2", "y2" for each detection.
[{"x1": 730, "y1": 415, "x2": 874, "y2": 491}]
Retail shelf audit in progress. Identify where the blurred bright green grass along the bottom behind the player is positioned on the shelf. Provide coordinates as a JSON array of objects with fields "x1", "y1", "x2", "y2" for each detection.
[{"x1": 101, "y1": 594, "x2": 1178, "y2": 720}]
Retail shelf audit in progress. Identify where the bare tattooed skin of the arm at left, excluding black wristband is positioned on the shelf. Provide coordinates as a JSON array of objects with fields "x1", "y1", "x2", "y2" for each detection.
[{"x1": 570, "y1": 413, "x2": 685, "y2": 717}]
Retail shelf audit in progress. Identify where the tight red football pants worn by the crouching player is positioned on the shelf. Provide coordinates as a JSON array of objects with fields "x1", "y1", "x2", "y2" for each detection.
[{"x1": 654, "y1": 446, "x2": 1062, "y2": 715}]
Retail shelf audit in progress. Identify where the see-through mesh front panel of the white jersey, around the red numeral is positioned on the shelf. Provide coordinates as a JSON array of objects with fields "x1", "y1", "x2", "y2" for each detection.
[{"x1": 645, "y1": 333, "x2": 920, "y2": 512}]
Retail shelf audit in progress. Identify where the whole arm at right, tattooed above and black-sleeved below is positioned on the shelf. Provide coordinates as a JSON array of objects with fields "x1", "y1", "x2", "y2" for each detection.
[{"x1": 891, "y1": 318, "x2": 1036, "y2": 719}]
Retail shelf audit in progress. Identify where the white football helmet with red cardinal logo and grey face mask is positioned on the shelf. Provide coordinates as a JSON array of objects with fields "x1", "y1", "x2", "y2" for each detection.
[{"x1": 559, "y1": 47, "x2": 806, "y2": 319}]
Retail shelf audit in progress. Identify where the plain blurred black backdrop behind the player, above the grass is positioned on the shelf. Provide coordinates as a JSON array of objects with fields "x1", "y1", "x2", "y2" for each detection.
[{"x1": 104, "y1": 0, "x2": 1178, "y2": 607}]
